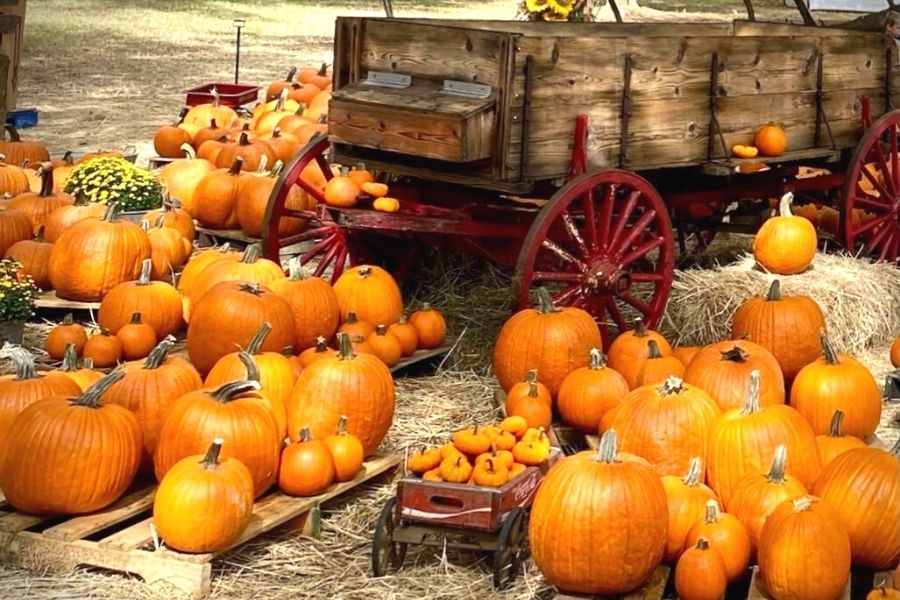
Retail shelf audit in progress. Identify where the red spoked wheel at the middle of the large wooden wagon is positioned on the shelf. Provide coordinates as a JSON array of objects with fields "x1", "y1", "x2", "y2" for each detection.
[{"x1": 515, "y1": 169, "x2": 675, "y2": 348}]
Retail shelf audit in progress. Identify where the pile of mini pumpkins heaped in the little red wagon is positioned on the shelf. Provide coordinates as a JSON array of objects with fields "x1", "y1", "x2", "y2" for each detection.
[{"x1": 406, "y1": 416, "x2": 550, "y2": 487}]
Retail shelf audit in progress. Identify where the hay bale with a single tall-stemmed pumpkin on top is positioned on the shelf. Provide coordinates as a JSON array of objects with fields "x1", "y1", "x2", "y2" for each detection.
[{"x1": 662, "y1": 253, "x2": 900, "y2": 353}]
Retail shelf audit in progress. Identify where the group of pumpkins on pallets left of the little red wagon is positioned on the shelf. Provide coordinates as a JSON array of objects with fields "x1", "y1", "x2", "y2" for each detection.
[{"x1": 0, "y1": 256, "x2": 446, "y2": 552}]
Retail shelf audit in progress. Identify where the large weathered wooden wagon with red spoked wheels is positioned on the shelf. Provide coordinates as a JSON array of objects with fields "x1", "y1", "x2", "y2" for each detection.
[{"x1": 263, "y1": 10, "x2": 900, "y2": 344}]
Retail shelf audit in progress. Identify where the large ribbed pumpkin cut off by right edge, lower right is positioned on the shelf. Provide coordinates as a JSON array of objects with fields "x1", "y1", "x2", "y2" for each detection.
[{"x1": 813, "y1": 442, "x2": 900, "y2": 570}]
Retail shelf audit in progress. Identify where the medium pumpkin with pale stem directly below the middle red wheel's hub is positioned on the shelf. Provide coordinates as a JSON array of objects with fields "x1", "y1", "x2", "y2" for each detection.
[{"x1": 556, "y1": 348, "x2": 629, "y2": 433}]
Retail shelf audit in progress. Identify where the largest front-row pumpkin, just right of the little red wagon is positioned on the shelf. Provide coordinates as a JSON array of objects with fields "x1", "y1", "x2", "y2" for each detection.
[{"x1": 528, "y1": 431, "x2": 668, "y2": 594}]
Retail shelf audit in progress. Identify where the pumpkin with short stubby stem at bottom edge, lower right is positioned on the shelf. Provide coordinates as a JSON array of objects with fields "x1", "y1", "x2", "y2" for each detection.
[{"x1": 759, "y1": 496, "x2": 850, "y2": 600}]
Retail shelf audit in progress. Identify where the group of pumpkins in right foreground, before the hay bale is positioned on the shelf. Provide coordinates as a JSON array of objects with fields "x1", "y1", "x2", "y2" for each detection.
[{"x1": 493, "y1": 282, "x2": 900, "y2": 600}]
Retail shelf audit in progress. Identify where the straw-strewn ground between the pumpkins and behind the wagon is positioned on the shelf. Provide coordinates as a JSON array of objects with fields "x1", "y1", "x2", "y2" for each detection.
[{"x1": 0, "y1": 0, "x2": 896, "y2": 600}]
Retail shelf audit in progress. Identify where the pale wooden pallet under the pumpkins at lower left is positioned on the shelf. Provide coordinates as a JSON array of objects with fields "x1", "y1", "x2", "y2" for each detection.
[{"x1": 0, "y1": 454, "x2": 403, "y2": 598}]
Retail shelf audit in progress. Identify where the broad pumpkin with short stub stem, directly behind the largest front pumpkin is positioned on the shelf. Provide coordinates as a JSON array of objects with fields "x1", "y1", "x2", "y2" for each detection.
[{"x1": 612, "y1": 376, "x2": 721, "y2": 476}]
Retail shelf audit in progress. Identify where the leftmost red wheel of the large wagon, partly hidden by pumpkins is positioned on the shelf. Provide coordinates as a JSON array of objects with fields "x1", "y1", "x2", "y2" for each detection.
[{"x1": 262, "y1": 136, "x2": 355, "y2": 282}]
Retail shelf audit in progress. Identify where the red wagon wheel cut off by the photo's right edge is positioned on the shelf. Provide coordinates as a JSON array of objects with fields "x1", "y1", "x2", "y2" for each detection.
[{"x1": 841, "y1": 111, "x2": 900, "y2": 262}]
